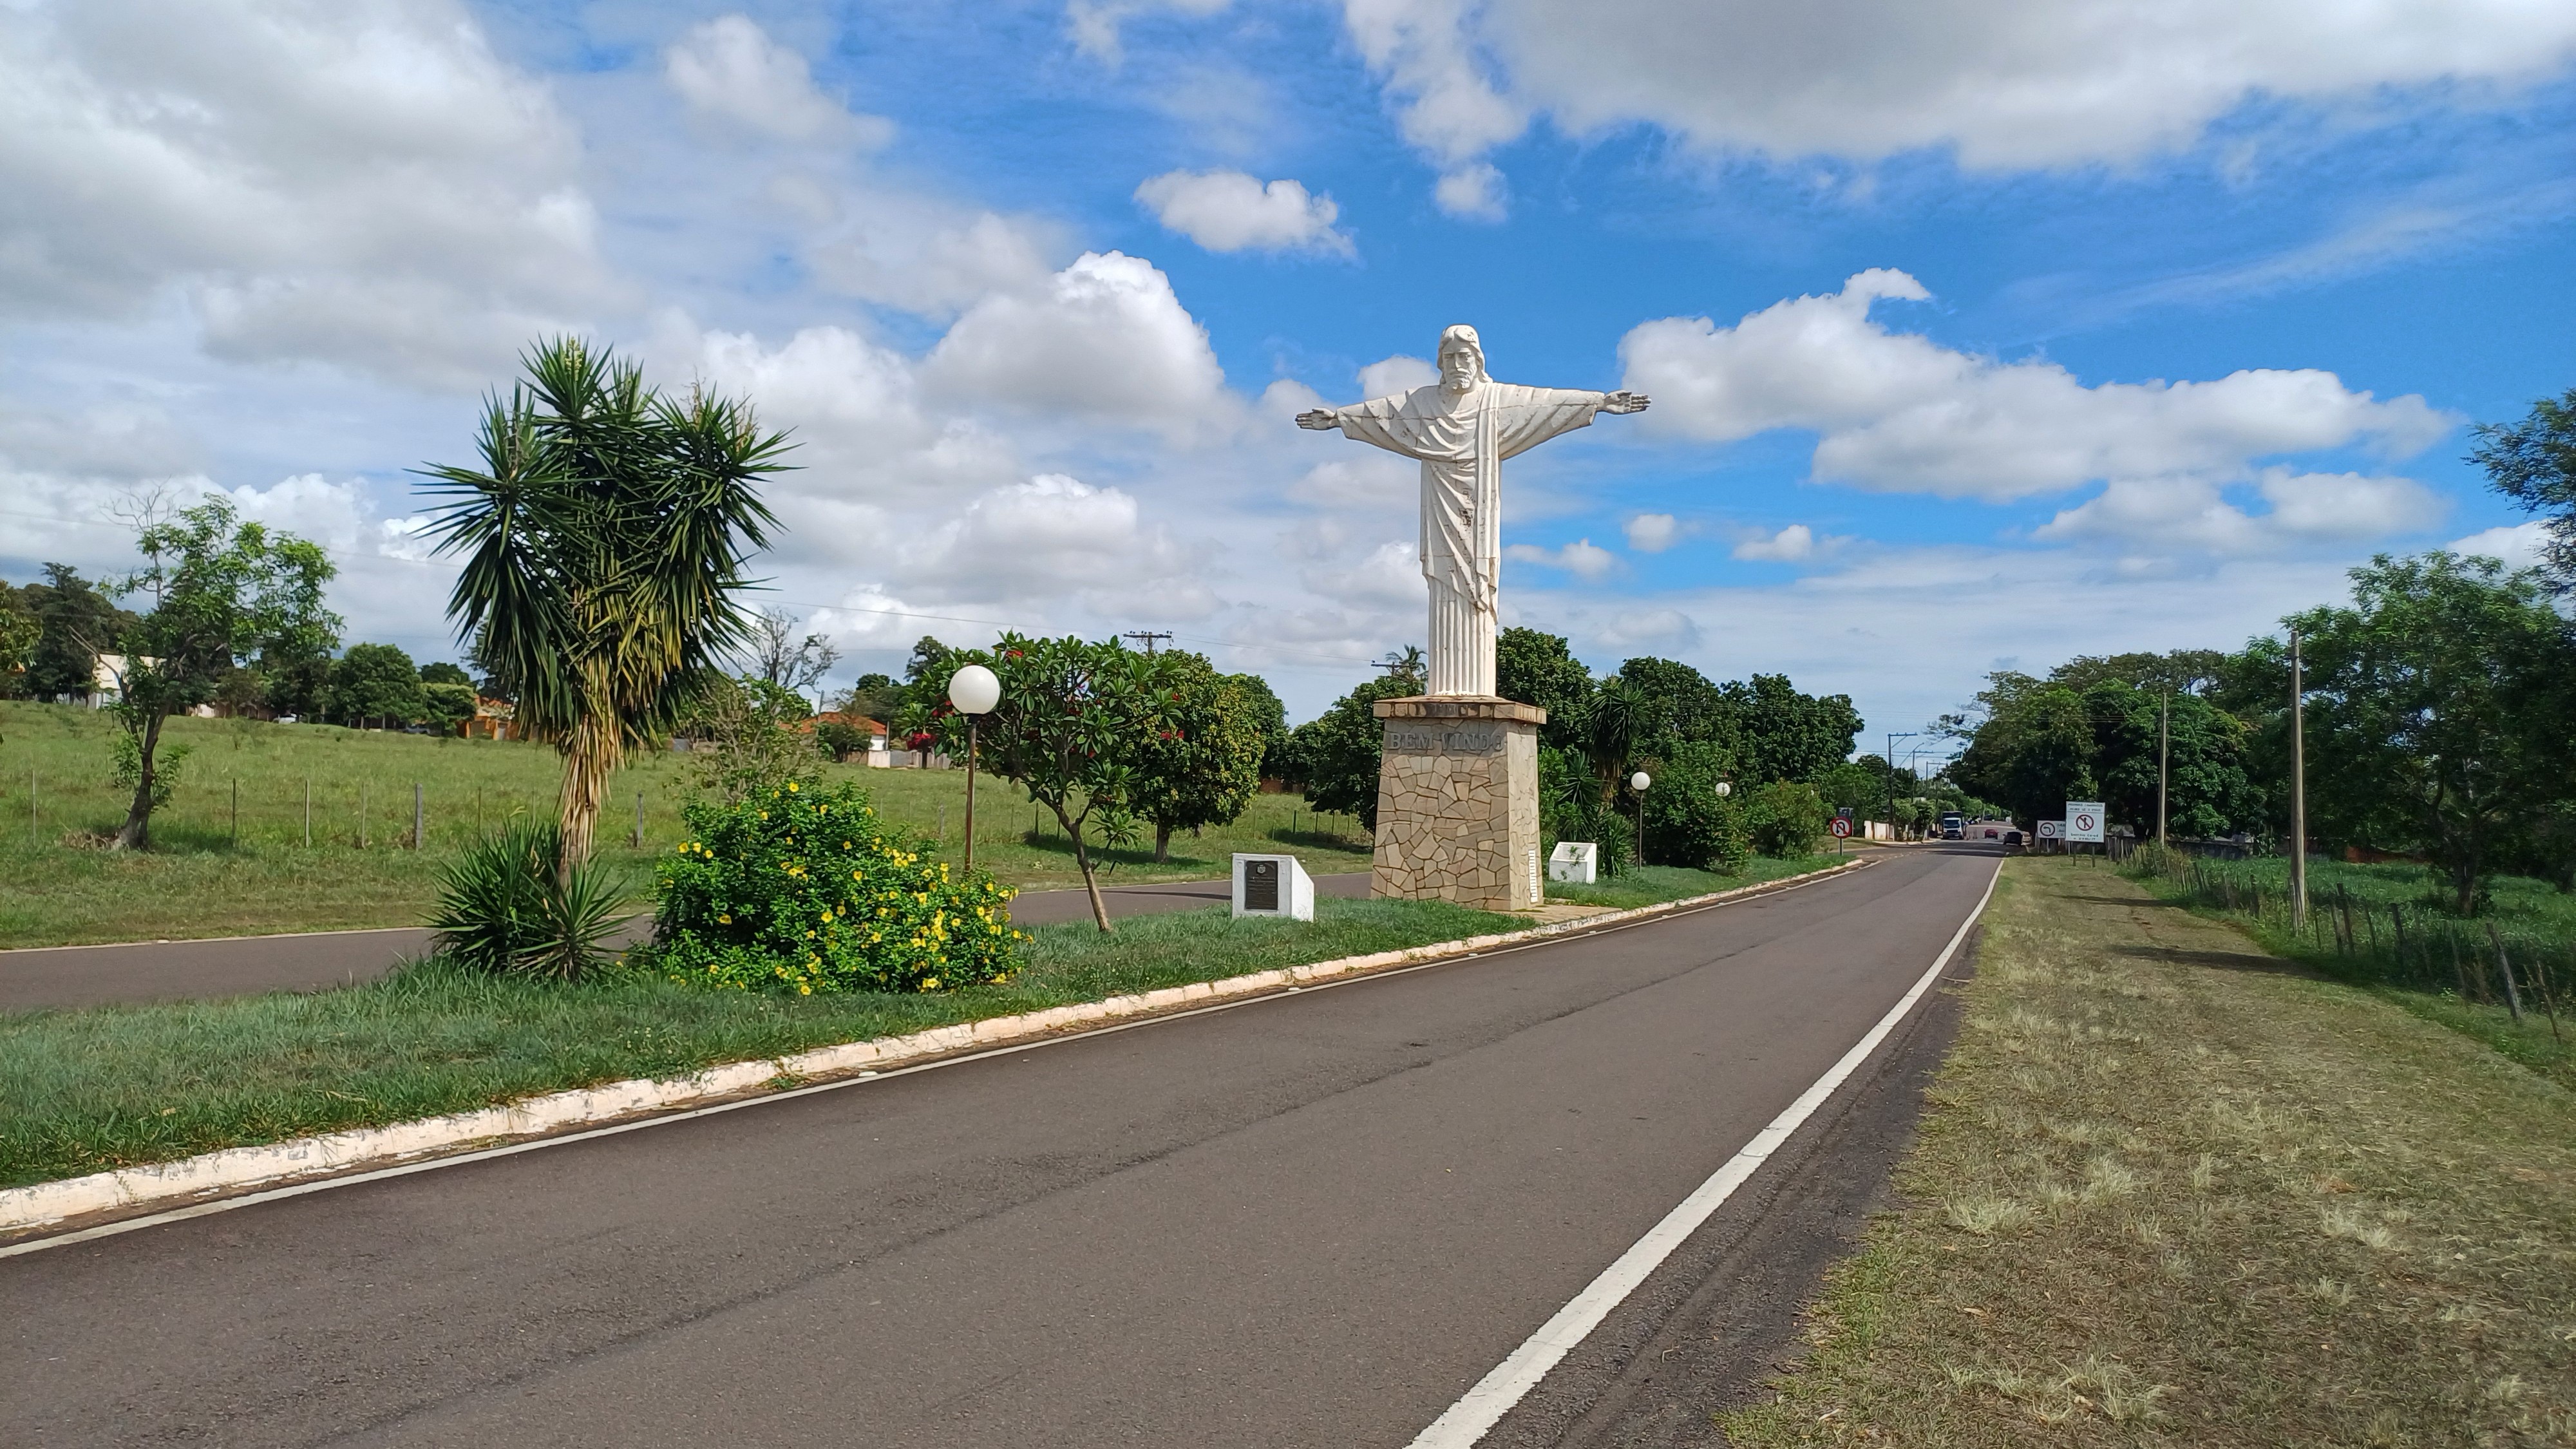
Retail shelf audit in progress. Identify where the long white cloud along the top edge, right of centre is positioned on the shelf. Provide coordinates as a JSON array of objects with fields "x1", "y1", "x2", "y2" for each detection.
[{"x1": 1342, "y1": 0, "x2": 2576, "y2": 170}]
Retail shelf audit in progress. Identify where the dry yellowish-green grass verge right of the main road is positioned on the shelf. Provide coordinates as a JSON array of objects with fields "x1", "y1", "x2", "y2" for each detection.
[{"x1": 1723, "y1": 858, "x2": 2576, "y2": 1446}]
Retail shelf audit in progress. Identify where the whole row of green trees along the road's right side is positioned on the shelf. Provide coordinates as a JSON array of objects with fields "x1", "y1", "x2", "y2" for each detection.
[{"x1": 1940, "y1": 381, "x2": 2576, "y2": 913}]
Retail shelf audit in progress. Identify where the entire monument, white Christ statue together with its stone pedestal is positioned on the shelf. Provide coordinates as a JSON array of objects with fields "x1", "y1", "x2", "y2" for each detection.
[{"x1": 1296, "y1": 327, "x2": 1646, "y2": 910}]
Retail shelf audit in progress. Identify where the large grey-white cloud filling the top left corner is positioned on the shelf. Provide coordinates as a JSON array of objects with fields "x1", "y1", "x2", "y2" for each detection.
[{"x1": 0, "y1": 0, "x2": 605, "y2": 387}]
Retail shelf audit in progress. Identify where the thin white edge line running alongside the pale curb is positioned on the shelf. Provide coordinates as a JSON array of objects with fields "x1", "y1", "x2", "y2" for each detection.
[{"x1": 0, "y1": 866, "x2": 1896, "y2": 1258}]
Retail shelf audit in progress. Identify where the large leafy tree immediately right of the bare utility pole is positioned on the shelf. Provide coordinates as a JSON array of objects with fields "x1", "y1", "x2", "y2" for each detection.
[{"x1": 2290, "y1": 552, "x2": 2576, "y2": 915}]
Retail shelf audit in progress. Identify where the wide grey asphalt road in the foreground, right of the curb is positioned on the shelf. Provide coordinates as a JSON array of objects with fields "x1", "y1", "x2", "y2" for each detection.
[{"x1": 0, "y1": 848, "x2": 1996, "y2": 1449}]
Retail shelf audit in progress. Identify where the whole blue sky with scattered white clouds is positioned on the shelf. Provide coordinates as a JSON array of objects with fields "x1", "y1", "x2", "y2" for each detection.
[{"x1": 0, "y1": 0, "x2": 2576, "y2": 732}]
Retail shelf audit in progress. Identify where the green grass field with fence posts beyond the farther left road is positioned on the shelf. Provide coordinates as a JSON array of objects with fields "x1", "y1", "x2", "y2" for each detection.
[{"x1": 0, "y1": 701, "x2": 1368, "y2": 949}]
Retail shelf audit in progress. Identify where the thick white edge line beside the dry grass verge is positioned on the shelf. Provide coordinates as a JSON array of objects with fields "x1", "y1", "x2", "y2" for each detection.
[{"x1": 1409, "y1": 861, "x2": 2004, "y2": 1449}]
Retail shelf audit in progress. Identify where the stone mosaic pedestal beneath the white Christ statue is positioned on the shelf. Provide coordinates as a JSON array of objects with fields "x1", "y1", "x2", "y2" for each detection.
[{"x1": 1368, "y1": 694, "x2": 1548, "y2": 910}]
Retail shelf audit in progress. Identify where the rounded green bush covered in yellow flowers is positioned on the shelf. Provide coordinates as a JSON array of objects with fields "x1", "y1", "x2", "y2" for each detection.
[{"x1": 649, "y1": 784, "x2": 1023, "y2": 995}]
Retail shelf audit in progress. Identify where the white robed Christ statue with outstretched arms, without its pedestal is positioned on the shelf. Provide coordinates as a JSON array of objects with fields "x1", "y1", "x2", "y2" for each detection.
[{"x1": 1296, "y1": 327, "x2": 1646, "y2": 696}]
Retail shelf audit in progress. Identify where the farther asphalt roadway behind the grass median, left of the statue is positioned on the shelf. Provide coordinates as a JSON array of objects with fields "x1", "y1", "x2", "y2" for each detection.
[{"x1": 0, "y1": 871, "x2": 1368, "y2": 1010}]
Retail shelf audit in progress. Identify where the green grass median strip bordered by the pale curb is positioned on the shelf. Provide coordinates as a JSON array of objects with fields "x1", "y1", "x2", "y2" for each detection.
[{"x1": 0, "y1": 900, "x2": 1528, "y2": 1186}]
